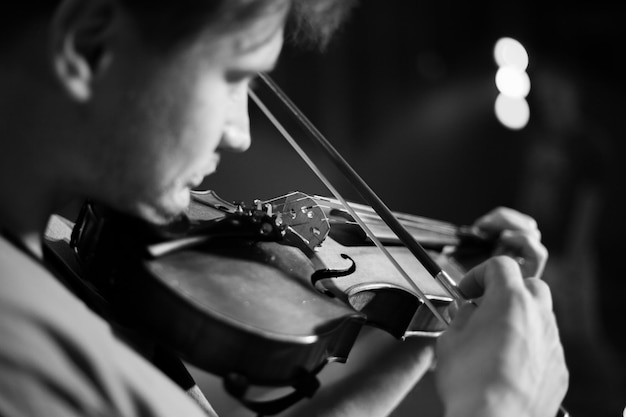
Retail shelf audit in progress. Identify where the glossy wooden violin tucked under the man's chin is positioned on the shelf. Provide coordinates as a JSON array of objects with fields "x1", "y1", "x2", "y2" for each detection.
[{"x1": 40, "y1": 187, "x2": 483, "y2": 414}]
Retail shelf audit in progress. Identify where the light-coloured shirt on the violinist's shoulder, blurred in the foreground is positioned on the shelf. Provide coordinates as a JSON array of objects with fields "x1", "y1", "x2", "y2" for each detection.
[{"x1": 0, "y1": 236, "x2": 213, "y2": 417}]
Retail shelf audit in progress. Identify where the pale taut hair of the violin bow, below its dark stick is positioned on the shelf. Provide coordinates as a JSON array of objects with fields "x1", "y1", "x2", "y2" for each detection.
[{"x1": 248, "y1": 90, "x2": 450, "y2": 326}]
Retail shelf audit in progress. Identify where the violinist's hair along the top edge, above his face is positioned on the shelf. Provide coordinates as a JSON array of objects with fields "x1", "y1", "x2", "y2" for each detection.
[{"x1": 0, "y1": 0, "x2": 356, "y2": 48}]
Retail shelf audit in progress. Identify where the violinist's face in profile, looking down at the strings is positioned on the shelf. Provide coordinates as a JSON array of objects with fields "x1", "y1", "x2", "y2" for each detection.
[{"x1": 88, "y1": 10, "x2": 283, "y2": 222}]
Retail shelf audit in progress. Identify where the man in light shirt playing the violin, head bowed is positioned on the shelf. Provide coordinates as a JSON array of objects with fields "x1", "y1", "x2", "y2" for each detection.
[{"x1": 0, "y1": 0, "x2": 567, "y2": 417}]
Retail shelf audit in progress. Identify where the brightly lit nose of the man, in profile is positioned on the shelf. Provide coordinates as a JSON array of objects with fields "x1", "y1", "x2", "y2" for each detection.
[{"x1": 220, "y1": 86, "x2": 251, "y2": 152}]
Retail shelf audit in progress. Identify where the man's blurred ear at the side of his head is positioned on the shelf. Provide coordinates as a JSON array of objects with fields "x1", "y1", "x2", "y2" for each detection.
[{"x1": 51, "y1": 0, "x2": 118, "y2": 102}]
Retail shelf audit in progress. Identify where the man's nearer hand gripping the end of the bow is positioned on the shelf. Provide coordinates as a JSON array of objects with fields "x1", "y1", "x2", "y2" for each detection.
[{"x1": 436, "y1": 256, "x2": 569, "y2": 417}]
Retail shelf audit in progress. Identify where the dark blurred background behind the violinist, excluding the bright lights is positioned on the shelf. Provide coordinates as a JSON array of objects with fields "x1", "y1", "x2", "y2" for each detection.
[{"x1": 200, "y1": 0, "x2": 626, "y2": 417}]
